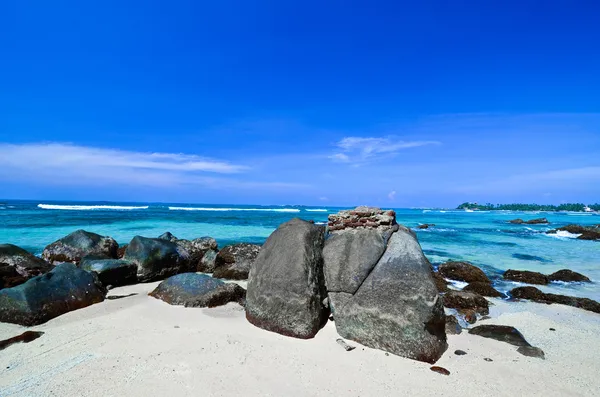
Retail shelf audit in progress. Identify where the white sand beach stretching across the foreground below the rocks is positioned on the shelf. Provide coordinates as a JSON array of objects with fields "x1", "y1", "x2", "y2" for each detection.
[{"x1": 0, "y1": 283, "x2": 600, "y2": 397}]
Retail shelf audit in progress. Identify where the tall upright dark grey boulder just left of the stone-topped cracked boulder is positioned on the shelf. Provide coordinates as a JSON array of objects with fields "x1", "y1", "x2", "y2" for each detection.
[{"x1": 246, "y1": 218, "x2": 329, "y2": 339}]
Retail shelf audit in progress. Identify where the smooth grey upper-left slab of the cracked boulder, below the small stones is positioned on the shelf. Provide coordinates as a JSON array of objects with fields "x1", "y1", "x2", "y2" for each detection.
[{"x1": 323, "y1": 229, "x2": 385, "y2": 294}]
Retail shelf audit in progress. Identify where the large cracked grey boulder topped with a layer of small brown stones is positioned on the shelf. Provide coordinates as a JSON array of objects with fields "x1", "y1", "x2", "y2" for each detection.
[{"x1": 323, "y1": 207, "x2": 447, "y2": 363}]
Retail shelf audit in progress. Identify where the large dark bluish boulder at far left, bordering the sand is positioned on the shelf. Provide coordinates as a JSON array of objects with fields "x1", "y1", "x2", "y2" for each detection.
[{"x1": 0, "y1": 263, "x2": 106, "y2": 326}]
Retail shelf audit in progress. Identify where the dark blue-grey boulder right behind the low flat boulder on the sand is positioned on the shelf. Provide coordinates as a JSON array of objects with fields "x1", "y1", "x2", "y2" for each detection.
[{"x1": 123, "y1": 236, "x2": 195, "y2": 282}]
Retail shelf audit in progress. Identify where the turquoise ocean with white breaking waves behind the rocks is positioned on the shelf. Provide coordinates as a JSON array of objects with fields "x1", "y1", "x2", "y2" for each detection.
[{"x1": 0, "y1": 201, "x2": 600, "y2": 300}]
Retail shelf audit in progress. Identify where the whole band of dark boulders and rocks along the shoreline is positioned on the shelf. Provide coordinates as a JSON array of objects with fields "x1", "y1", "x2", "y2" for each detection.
[{"x1": 0, "y1": 207, "x2": 600, "y2": 363}]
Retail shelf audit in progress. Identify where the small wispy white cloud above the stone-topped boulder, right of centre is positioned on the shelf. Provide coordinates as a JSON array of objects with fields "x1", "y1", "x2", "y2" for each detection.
[{"x1": 329, "y1": 136, "x2": 441, "y2": 162}]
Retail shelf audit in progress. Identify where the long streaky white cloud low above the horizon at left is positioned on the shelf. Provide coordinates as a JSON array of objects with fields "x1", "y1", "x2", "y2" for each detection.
[{"x1": 0, "y1": 143, "x2": 307, "y2": 190}]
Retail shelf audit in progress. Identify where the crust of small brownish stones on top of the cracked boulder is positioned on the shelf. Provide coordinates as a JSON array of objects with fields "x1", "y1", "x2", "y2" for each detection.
[{"x1": 327, "y1": 206, "x2": 396, "y2": 232}]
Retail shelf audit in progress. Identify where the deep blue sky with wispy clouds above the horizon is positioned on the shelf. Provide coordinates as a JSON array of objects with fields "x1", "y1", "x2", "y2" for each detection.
[{"x1": 0, "y1": 1, "x2": 600, "y2": 207}]
